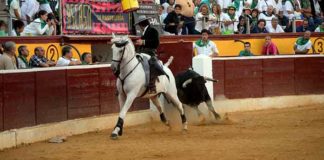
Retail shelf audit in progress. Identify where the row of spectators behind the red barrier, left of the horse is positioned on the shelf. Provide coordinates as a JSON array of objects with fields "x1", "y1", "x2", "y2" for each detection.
[{"x1": 0, "y1": 41, "x2": 93, "y2": 70}]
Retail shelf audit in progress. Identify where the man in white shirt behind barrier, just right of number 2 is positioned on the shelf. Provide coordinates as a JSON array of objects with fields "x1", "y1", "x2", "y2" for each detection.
[{"x1": 56, "y1": 46, "x2": 81, "y2": 67}]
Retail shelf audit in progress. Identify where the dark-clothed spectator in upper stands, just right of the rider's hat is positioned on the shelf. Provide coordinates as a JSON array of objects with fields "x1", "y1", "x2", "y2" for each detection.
[{"x1": 164, "y1": 4, "x2": 183, "y2": 35}]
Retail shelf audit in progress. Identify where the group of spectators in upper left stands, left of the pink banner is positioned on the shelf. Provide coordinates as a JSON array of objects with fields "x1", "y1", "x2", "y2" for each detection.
[{"x1": 0, "y1": 0, "x2": 58, "y2": 36}]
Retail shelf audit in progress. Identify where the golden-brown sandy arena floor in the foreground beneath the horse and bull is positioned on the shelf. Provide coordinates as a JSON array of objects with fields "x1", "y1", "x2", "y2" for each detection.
[{"x1": 0, "y1": 105, "x2": 324, "y2": 160}]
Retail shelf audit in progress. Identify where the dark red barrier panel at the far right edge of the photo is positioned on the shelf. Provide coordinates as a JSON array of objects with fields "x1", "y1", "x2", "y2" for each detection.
[{"x1": 295, "y1": 57, "x2": 324, "y2": 94}]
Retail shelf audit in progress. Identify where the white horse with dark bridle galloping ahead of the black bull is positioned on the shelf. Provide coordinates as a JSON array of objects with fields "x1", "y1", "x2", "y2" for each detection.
[{"x1": 111, "y1": 35, "x2": 187, "y2": 139}]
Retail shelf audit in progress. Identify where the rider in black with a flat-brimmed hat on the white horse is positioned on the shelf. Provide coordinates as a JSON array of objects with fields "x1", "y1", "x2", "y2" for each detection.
[{"x1": 135, "y1": 15, "x2": 167, "y2": 93}]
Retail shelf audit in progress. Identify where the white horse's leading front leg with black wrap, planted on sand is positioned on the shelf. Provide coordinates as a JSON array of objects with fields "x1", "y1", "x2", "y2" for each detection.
[{"x1": 110, "y1": 93, "x2": 136, "y2": 139}]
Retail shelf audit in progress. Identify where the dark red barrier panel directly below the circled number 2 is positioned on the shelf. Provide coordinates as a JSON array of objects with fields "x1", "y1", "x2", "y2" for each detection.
[{"x1": 36, "y1": 70, "x2": 67, "y2": 124}]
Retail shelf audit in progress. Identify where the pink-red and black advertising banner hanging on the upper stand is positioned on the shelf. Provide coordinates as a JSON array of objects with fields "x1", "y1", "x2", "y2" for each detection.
[{"x1": 62, "y1": 0, "x2": 129, "y2": 34}]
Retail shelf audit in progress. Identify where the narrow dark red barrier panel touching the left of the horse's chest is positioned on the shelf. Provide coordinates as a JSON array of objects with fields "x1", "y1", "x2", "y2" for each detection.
[{"x1": 99, "y1": 68, "x2": 119, "y2": 114}]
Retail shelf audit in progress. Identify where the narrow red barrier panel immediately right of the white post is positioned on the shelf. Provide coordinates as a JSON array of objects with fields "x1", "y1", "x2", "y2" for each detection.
[{"x1": 213, "y1": 60, "x2": 225, "y2": 98}]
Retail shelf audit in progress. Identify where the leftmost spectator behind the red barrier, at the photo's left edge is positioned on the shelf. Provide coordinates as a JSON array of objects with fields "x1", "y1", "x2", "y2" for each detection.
[{"x1": 0, "y1": 41, "x2": 17, "y2": 70}]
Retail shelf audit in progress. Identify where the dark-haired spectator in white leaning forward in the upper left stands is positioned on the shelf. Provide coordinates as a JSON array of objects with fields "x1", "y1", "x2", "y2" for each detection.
[{"x1": 21, "y1": 10, "x2": 56, "y2": 36}]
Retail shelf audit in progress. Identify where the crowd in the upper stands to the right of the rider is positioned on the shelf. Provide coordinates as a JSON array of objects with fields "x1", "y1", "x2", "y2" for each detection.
[{"x1": 159, "y1": 0, "x2": 324, "y2": 35}]
